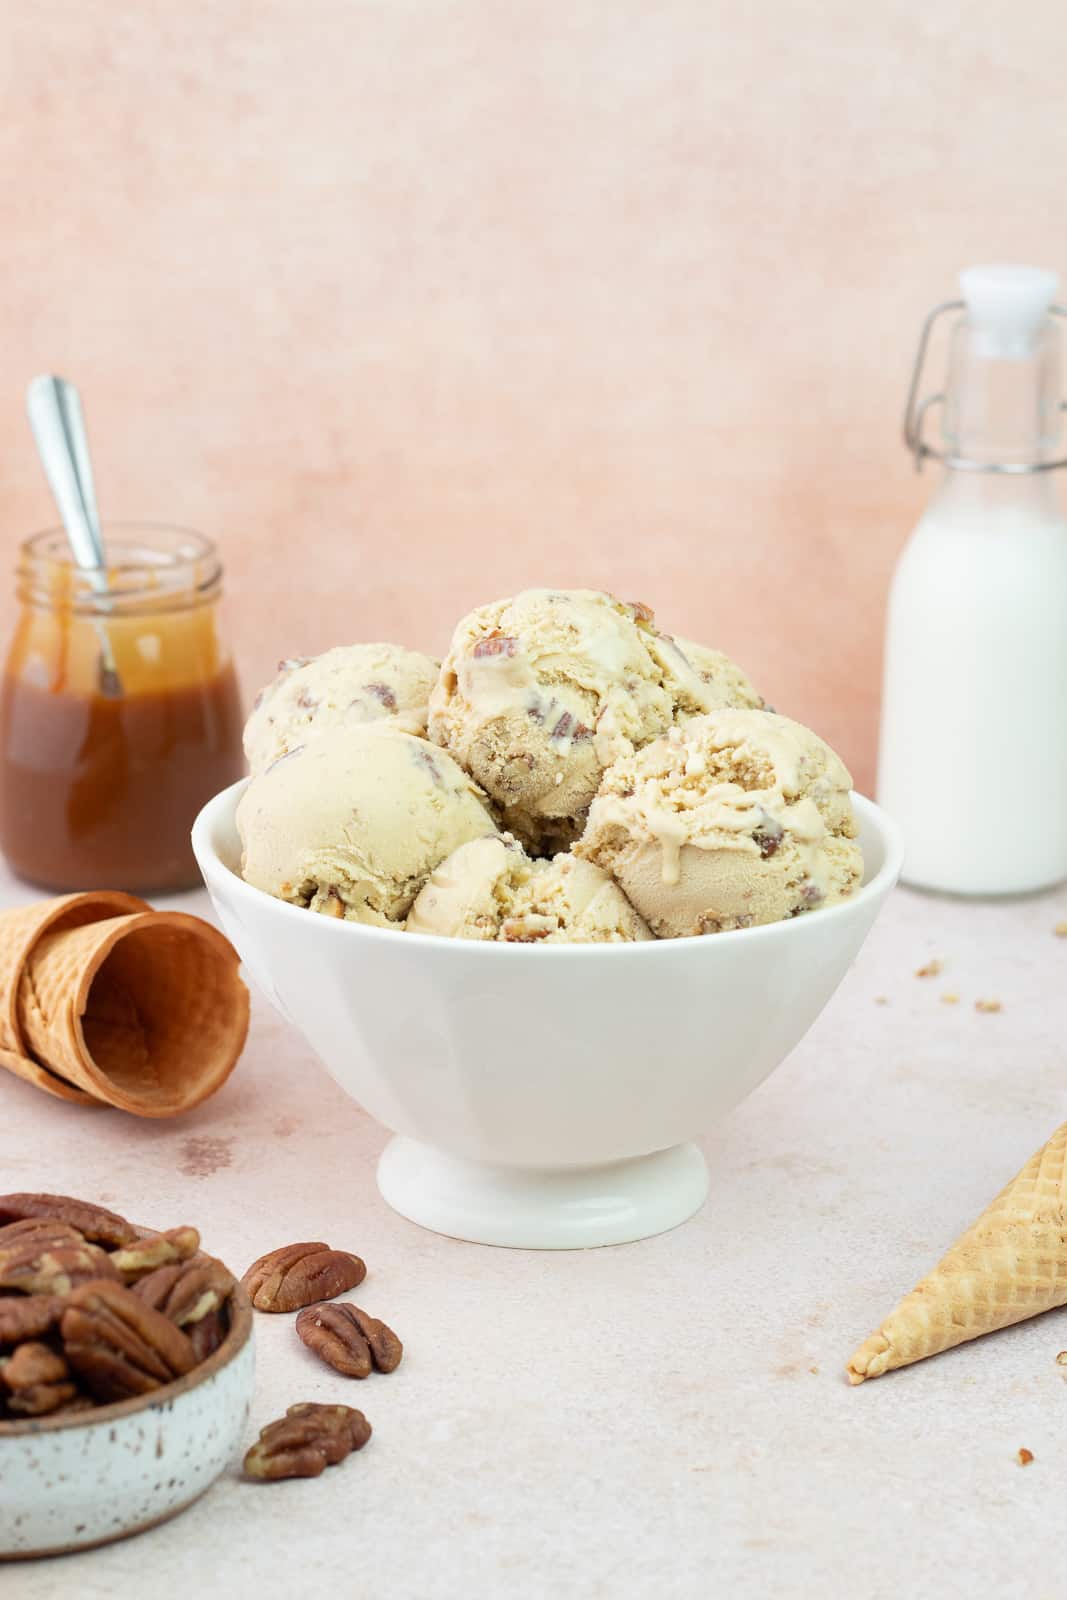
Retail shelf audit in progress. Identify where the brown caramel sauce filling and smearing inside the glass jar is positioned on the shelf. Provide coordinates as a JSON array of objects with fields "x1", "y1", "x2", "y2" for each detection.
[{"x1": 0, "y1": 579, "x2": 243, "y2": 893}]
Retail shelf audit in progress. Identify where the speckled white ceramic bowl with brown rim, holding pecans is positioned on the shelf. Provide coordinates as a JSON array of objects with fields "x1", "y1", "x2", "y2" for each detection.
[{"x1": 0, "y1": 1285, "x2": 254, "y2": 1560}]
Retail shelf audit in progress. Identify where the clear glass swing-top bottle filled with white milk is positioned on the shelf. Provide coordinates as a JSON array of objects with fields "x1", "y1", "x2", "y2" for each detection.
[{"x1": 878, "y1": 275, "x2": 1067, "y2": 894}]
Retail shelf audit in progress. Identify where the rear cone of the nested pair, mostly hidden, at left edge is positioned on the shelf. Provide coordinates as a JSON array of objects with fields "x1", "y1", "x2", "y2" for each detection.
[{"x1": 0, "y1": 890, "x2": 149, "y2": 1106}]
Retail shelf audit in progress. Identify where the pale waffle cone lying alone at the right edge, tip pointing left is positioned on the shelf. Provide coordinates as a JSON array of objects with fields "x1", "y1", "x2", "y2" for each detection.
[{"x1": 848, "y1": 1123, "x2": 1067, "y2": 1384}]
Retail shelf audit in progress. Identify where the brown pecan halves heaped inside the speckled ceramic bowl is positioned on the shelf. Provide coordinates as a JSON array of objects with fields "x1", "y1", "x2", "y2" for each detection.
[{"x1": 0, "y1": 1194, "x2": 235, "y2": 1421}]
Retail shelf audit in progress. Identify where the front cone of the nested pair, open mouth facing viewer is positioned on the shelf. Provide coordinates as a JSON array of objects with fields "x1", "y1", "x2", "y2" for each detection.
[{"x1": 18, "y1": 910, "x2": 248, "y2": 1117}]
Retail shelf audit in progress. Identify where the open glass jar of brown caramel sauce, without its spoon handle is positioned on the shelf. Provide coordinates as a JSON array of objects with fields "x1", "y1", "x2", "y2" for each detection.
[{"x1": 0, "y1": 523, "x2": 243, "y2": 893}]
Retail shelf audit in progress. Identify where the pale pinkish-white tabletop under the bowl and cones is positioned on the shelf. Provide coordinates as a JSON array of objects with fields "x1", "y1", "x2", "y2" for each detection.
[{"x1": 0, "y1": 869, "x2": 1067, "y2": 1600}]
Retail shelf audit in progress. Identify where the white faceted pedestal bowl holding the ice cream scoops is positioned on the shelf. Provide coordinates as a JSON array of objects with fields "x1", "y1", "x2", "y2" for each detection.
[{"x1": 192, "y1": 784, "x2": 901, "y2": 1250}]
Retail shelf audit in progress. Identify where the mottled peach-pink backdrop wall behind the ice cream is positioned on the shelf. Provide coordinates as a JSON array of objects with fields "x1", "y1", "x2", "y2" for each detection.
[{"x1": 0, "y1": 0, "x2": 1067, "y2": 786}]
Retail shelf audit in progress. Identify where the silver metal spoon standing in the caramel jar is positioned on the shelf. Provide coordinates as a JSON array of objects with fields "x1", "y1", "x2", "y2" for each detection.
[{"x1": 26, "y1": 373, "x2": 122, "y2": 699}]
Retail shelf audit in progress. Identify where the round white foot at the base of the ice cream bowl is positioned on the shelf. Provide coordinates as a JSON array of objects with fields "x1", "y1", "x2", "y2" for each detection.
[{"x1": 378, "y1": 1136, "x2": 707, "y2": 1250}]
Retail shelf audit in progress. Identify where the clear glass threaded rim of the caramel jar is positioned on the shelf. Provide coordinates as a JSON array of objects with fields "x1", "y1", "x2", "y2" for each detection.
[{"x1": 18, "y1": 520, "x2": 222, "y2": 613}]
